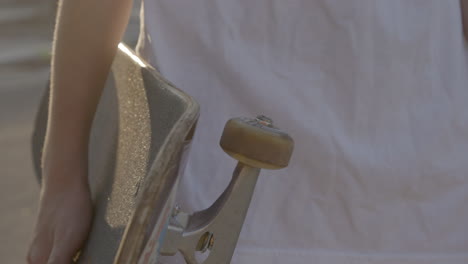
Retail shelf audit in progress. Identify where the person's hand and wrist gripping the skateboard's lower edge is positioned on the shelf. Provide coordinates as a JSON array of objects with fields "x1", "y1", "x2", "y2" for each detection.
[{"x1": 28, "y1": 161, "x2": 92, "y2": 264}]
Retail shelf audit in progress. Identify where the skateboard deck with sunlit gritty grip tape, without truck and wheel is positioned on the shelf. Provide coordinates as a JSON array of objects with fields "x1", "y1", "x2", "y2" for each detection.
[{"x1": 33, "y1": 44, "x2": 199, "y2": 264}]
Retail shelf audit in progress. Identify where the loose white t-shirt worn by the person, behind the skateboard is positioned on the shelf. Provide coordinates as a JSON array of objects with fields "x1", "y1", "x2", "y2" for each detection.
[{"x1": 137, "y1": 0, "x2": 468, "y2": 264}]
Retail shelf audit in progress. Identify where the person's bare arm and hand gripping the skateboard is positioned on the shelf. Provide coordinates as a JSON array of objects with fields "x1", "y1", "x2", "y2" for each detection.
[{"x1": 28, "y1": 0, "x2": 132, "y2": 264}]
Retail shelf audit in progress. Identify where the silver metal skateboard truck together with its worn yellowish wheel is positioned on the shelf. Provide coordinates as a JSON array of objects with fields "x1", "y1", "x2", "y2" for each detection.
[{"x1": 160, "y1": 116, "x2": 294, "y2": 264}]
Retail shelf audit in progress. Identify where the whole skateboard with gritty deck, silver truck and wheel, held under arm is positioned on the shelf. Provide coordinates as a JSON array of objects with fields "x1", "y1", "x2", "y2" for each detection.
[{"x1": 32, "y1": 44, "x2": 294, "y2": 264}]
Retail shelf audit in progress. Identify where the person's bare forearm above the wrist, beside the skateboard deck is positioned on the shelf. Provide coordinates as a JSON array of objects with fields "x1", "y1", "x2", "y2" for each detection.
[{"x1": 43, "y1": 0, "x2": 132, "y2": 180}]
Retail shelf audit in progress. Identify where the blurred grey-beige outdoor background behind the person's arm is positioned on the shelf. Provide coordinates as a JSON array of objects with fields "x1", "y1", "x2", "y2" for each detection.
[{"x1": 0, "y1": 0, "x2": 140, "y2": 264}]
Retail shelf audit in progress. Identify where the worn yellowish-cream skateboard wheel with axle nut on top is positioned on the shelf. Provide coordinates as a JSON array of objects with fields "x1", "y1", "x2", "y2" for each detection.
[{"x1": 220, "y1": 116, "x2": 294, "y2": 169}]
